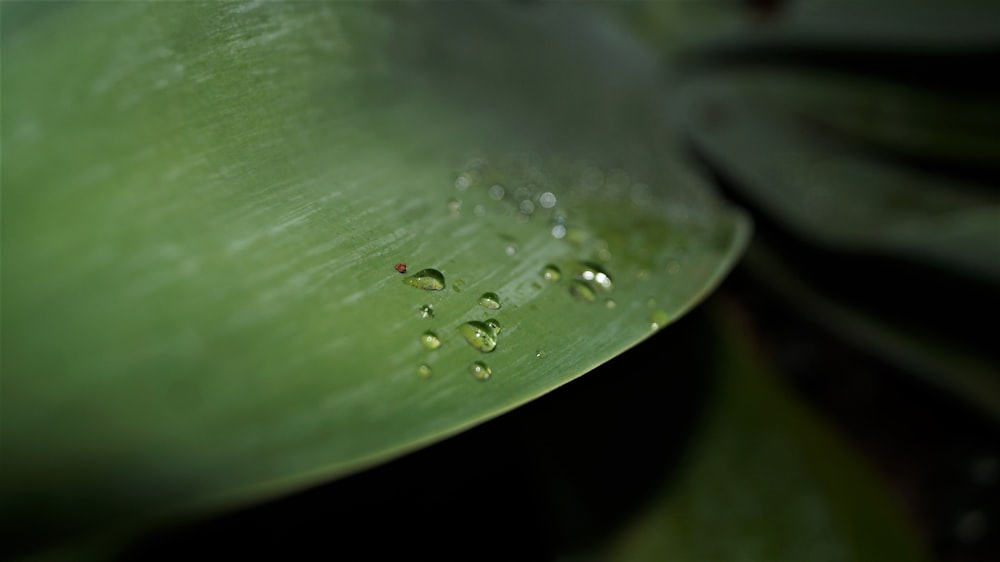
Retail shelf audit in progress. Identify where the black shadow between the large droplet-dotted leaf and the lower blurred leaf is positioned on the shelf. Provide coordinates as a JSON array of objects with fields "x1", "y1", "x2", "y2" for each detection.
[{"x1": 118, "y1": 306, "x2": 712, "y2": 561}]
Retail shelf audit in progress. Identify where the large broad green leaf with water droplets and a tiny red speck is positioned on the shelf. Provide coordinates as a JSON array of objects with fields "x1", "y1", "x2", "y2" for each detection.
[{"x1": 0, "y1": 2, "x2": 749, "y2": 552}]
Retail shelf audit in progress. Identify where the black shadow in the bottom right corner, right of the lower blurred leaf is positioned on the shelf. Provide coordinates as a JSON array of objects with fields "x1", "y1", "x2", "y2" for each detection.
[{"x1": 731, "y1": 268, "x2": 1000, "y2": 562}]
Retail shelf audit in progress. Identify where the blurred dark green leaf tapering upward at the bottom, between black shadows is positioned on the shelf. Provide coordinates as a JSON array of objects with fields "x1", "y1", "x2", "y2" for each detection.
[{"x1": 594, "y1": 303, "x2": 925, "y2": 561}]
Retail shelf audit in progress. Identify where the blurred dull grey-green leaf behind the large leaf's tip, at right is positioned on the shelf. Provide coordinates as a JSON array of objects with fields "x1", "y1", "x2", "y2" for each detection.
[{"x1": 677, "y1": 68, "x2": 1000, "y2": 281}]
